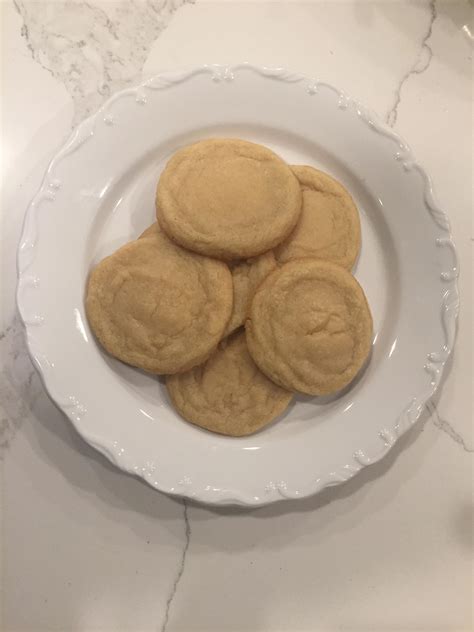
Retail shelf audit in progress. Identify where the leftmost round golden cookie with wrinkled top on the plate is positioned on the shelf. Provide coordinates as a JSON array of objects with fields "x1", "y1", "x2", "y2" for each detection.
[{"x1": 86, "y1": 228, "x2": 232, "y2": 374}]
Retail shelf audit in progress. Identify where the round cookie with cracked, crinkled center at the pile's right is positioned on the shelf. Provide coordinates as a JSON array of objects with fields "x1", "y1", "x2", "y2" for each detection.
[{"x1": 245, "y1": 258, "x2": 372, "y2": 395}]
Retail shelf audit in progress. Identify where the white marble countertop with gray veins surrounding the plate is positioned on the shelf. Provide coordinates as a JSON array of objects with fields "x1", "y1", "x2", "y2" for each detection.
[{"x1": 0, "y1": 0, "x2": 473, "y2": 632}]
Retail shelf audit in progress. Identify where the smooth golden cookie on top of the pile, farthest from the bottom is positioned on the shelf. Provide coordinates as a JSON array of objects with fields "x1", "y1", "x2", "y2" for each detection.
[{"x1": 156, "y1": 138, "x2": 302, "y2": 261}]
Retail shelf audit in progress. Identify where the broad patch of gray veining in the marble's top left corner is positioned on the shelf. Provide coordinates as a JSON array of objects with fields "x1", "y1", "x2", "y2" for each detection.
[{"x1": 14, "y1": 0, "x2": 193, "y2": 125}]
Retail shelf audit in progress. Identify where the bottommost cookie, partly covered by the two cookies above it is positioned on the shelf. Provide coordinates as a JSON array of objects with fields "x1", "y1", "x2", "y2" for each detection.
[{"x1": 166, "y1": 331, "x2": 293, "y2": 437}]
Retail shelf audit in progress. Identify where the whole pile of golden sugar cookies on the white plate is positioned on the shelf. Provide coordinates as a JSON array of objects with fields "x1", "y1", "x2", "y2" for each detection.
[{"x1": 86, "y1": 139, "x2": 372, "y2": 436}]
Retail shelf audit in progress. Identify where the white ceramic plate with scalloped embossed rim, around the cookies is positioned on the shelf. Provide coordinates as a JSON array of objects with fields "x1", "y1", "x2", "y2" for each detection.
[{"x1": 18, "y1": 64, "x2": 459, "y2": 505}]
